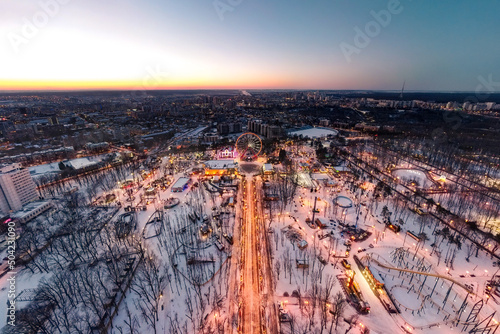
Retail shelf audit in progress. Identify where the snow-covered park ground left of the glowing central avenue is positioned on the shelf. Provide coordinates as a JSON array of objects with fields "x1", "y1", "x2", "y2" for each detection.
[{"x1": 0, "y1": 153, "x2": 235, "y2": 333}]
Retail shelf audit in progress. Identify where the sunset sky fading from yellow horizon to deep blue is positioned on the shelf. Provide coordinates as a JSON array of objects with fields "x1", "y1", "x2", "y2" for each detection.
[{"x1": 0, "y1": 0, "x2": 500, "y2": 91}]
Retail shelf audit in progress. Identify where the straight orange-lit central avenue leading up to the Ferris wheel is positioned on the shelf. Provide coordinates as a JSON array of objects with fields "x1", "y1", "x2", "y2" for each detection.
[{"x1": 226, "y1": 170, "x2": 279, "y2": 334}]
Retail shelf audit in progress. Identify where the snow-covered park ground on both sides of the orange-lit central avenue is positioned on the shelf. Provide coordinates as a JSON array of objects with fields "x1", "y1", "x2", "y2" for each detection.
[{"x1": 0, "y1": 141, "x2": 500, "y2": 334}]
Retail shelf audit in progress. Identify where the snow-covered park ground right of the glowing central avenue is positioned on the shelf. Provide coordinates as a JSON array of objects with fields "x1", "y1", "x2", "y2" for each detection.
[{"x1": 265, "y1": 145, "x2": 500, "y2": 334}]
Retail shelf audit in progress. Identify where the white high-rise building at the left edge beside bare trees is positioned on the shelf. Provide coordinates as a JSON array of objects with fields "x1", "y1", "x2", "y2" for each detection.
[{"x1": 0, "y1": 164, "x2": 38, "y2": 215}]
